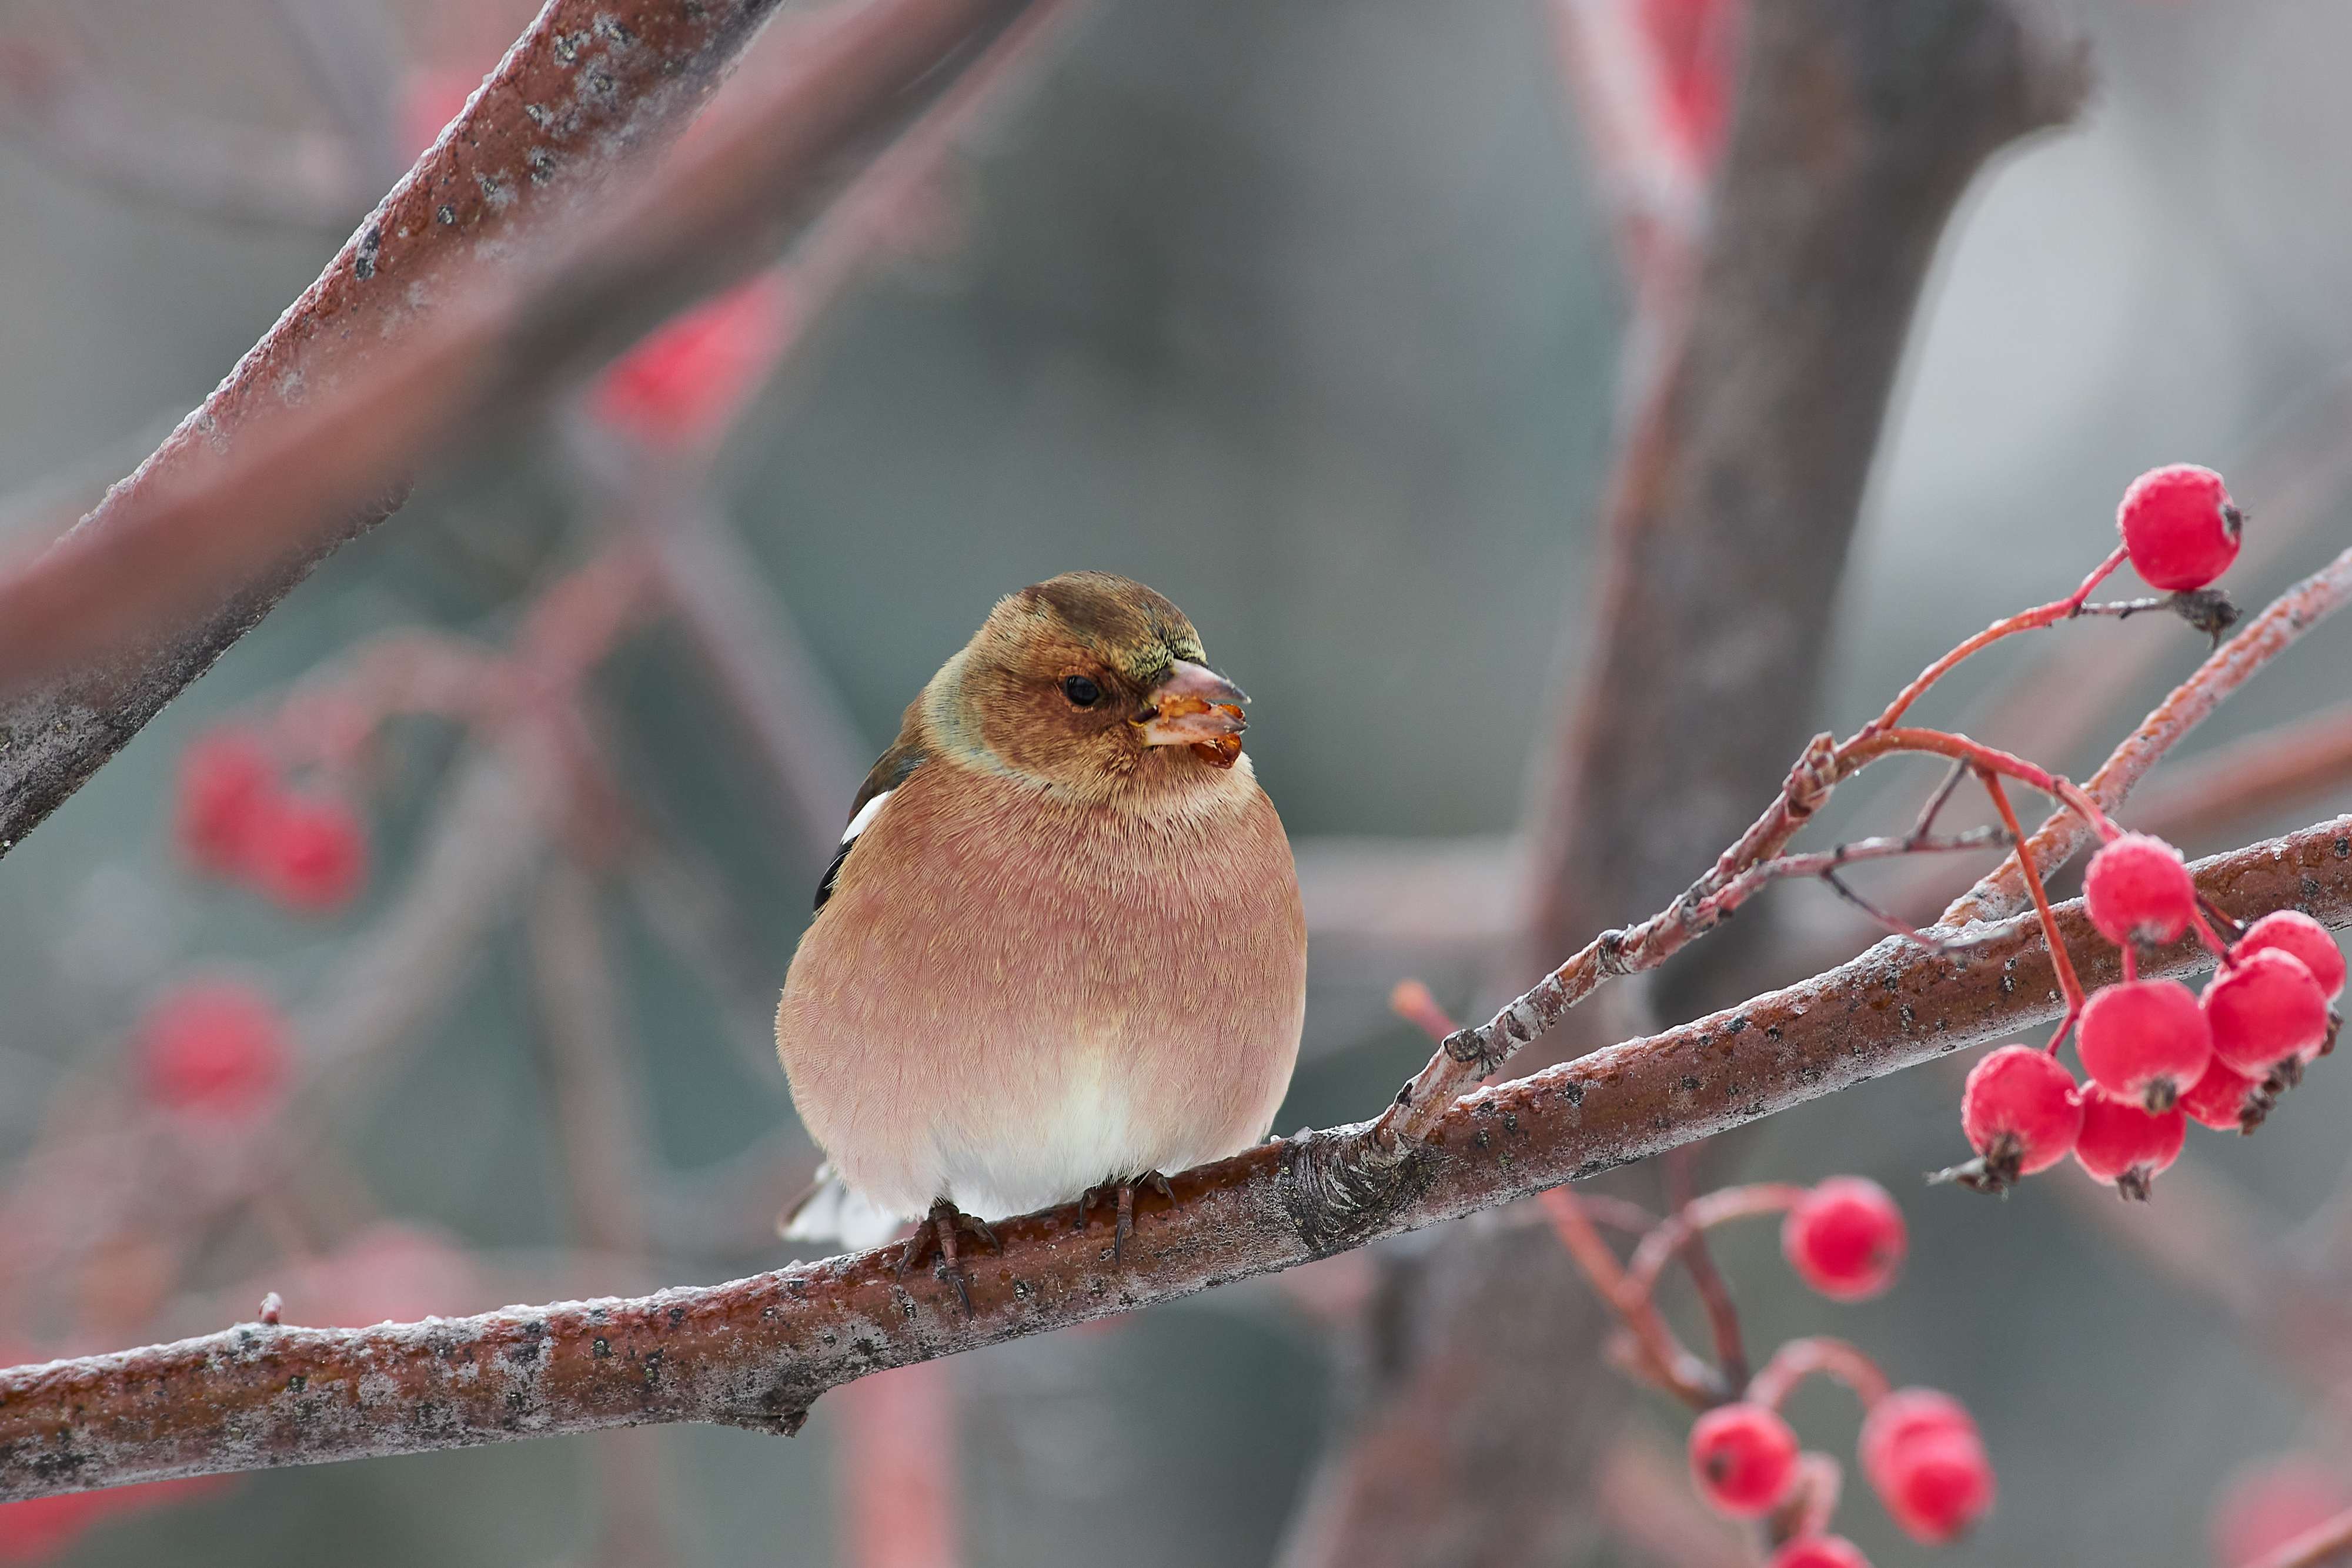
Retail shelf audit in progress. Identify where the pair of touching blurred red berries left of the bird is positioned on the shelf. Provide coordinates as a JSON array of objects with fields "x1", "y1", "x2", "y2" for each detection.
[{"x1": 174, "y1": 729, "x2": 367, "y2": 914}]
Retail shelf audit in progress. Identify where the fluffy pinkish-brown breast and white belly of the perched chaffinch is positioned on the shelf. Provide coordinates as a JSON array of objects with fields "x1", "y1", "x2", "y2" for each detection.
[{"x1": 776, "y1": 769, "x2": 1305, "y2": 1213}]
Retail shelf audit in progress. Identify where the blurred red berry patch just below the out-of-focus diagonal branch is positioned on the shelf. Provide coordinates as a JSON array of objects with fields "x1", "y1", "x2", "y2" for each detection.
[{"x1": 590, "y1": 273, "x2": 793, "y2": 447}]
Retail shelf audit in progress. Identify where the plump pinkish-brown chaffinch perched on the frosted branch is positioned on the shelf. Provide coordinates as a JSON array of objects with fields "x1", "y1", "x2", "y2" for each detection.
[{"x1": 776, "y1": 571, "x2": 1308, "y2": 1312}]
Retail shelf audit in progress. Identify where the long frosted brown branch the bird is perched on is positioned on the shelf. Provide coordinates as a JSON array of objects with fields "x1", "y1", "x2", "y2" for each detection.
[{"x1": 0, "y1": 815, "x2": 2352, "y2": 1497}]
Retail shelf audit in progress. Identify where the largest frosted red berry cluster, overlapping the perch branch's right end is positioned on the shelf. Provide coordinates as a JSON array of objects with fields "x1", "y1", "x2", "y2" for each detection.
[{"x1": 1959, "y1": 832, "x2": 2345, "y2": 1196}]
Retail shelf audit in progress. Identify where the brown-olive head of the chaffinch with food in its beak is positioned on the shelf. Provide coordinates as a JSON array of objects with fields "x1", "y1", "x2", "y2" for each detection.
[{"x1": 924, "y1": 571, "x2": 1249, "y2": 797}]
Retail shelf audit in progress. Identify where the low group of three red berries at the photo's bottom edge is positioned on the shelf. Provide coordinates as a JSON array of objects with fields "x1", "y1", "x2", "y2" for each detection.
[{"x1": 1691, "y1": 1389, "x2": 1997, "y2": 1568}]
